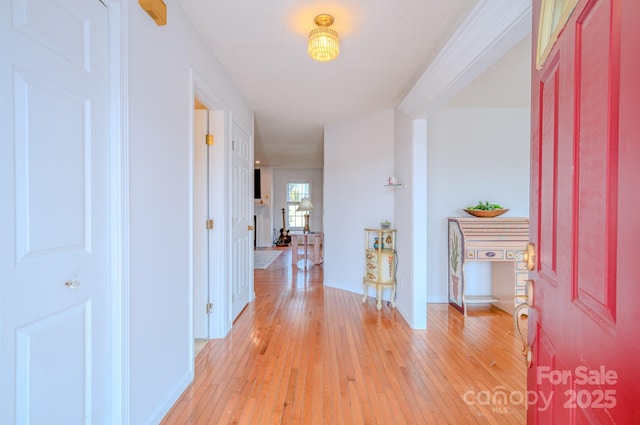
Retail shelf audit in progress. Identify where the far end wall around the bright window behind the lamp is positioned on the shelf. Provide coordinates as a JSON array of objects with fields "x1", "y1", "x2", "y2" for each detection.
[{"x1": 271, "y1": 168, "x2": 324, "y2": 234}]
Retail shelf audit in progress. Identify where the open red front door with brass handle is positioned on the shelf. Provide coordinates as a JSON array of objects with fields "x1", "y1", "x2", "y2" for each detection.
[{"x1": 528, "y1": 0, "x2": 640, "y2": 425}]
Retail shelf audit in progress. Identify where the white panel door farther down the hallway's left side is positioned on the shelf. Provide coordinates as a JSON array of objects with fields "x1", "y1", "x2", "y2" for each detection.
[{"x1": 231, "y1": 121, "x2": 253, "y2": 320}]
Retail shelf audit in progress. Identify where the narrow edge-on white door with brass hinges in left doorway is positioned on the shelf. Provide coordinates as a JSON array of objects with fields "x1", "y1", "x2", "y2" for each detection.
[{"x1": 193, "y1": 109, "x2": 212, "y2": 339}]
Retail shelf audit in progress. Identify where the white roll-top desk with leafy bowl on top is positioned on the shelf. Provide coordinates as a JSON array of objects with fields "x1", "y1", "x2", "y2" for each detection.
[{"x1": 448, "y1": 217, "x2": 529, "y2": 316}]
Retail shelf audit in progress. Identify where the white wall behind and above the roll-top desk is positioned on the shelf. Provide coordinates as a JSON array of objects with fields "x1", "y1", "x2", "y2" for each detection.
[{"x1": 427, "y1": 108, "x2": 530, "y2": 302}]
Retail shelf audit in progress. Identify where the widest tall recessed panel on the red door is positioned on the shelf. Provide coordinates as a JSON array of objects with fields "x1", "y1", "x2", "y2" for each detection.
[{"x1": 573, "y1": 1, "x2": 620, "y2": 325}]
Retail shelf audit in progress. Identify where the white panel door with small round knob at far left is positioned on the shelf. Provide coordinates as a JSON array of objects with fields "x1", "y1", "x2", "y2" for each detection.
[{"x1": 0, "y1": 0, "x2": 110, "y2": 424}]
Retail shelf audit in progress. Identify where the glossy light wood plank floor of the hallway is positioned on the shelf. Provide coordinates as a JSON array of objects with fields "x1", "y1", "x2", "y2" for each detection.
[{"x1": 162, "y1": 250, "x2": 526, "y2": 425}]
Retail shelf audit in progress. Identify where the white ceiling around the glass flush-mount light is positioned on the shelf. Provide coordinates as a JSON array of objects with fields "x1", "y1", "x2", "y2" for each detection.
[{"x1": 178, "y1": 0, "x2": 531, "y2": 168}]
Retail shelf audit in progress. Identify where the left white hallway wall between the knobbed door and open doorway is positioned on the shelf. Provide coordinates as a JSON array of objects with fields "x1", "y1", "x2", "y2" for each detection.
[{"x1": 125, "y1": 1, "x2": 253, "y2": 425}]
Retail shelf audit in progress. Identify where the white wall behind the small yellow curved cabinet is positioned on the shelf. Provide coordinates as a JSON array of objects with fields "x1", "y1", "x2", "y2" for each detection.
[{"x1": 324, "y1": 109, "x2": 396, "y2": 299}]
